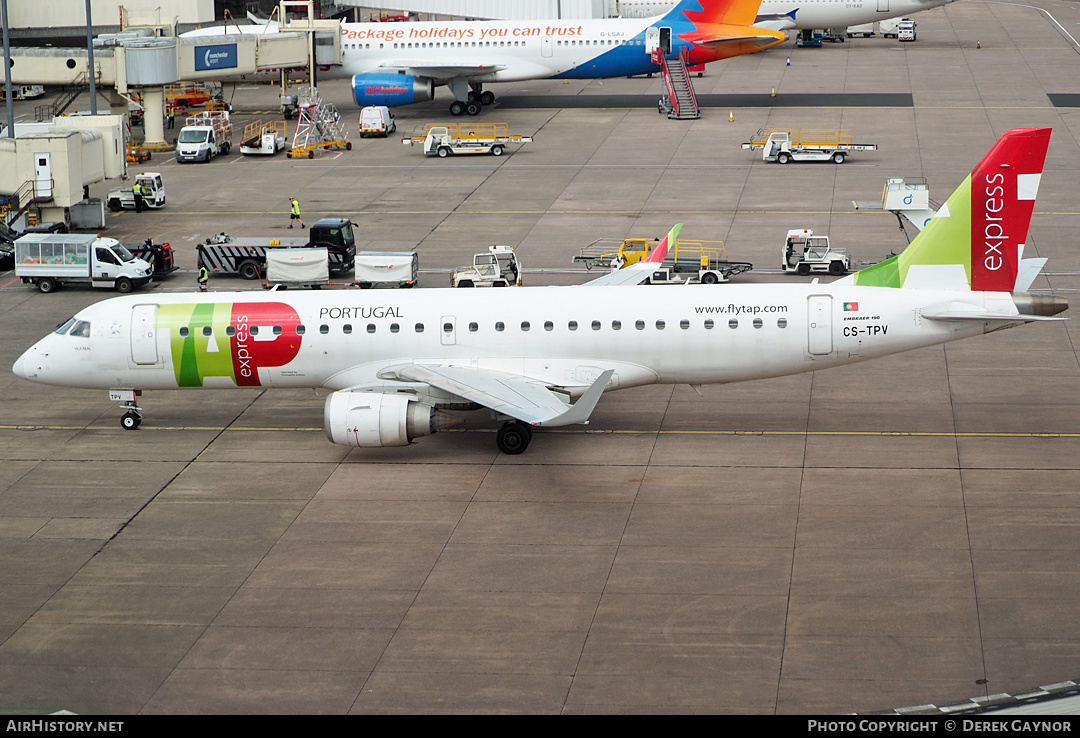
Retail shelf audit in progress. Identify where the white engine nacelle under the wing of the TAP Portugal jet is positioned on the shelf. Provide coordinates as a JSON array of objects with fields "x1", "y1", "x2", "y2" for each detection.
[{"x1": 323, "y1": 390, "x2": 461, "y2": 448}]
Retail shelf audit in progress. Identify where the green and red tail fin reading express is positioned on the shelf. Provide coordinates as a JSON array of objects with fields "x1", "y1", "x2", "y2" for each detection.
[{"x1": 854, "y1": 129, "x2": 1050, "y2": 292}]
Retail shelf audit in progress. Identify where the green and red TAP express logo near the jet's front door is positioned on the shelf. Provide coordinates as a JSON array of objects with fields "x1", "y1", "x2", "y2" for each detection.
[{"x1": 158, "y1": 303, "x2": 302, "y2": 387}]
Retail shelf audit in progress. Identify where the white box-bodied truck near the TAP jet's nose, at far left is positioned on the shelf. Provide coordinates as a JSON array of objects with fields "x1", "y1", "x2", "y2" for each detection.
[{"x1": 15, "y1": 233, "x2": 153, "y2": 294}]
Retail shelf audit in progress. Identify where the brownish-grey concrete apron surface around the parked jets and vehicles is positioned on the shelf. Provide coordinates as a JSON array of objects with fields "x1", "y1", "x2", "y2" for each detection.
[{"x1": 0, "y1": 0, "x2": 1080, "y2": 715}]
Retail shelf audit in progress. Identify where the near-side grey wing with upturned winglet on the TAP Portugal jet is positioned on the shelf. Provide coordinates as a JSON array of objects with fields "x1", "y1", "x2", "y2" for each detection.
[{"x1": 395, "y1": 364, "x2": 615, "y2": 426}]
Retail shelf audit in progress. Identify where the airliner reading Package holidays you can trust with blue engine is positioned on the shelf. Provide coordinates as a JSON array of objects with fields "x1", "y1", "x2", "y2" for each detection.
[{"x1": 190, "y1": 0, "x2": 786, "y2": 116}]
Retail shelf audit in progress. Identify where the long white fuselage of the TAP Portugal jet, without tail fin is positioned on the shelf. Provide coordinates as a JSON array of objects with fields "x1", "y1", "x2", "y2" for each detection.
[{"x1": 14, "y1": 284, "x2": 1016, "y2": 395}]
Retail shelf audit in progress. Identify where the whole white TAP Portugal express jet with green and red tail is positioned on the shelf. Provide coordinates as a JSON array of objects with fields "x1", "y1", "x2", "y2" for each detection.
[{"x1": 13, "y1": 129, "x2": 1068, "y2": 454}]
